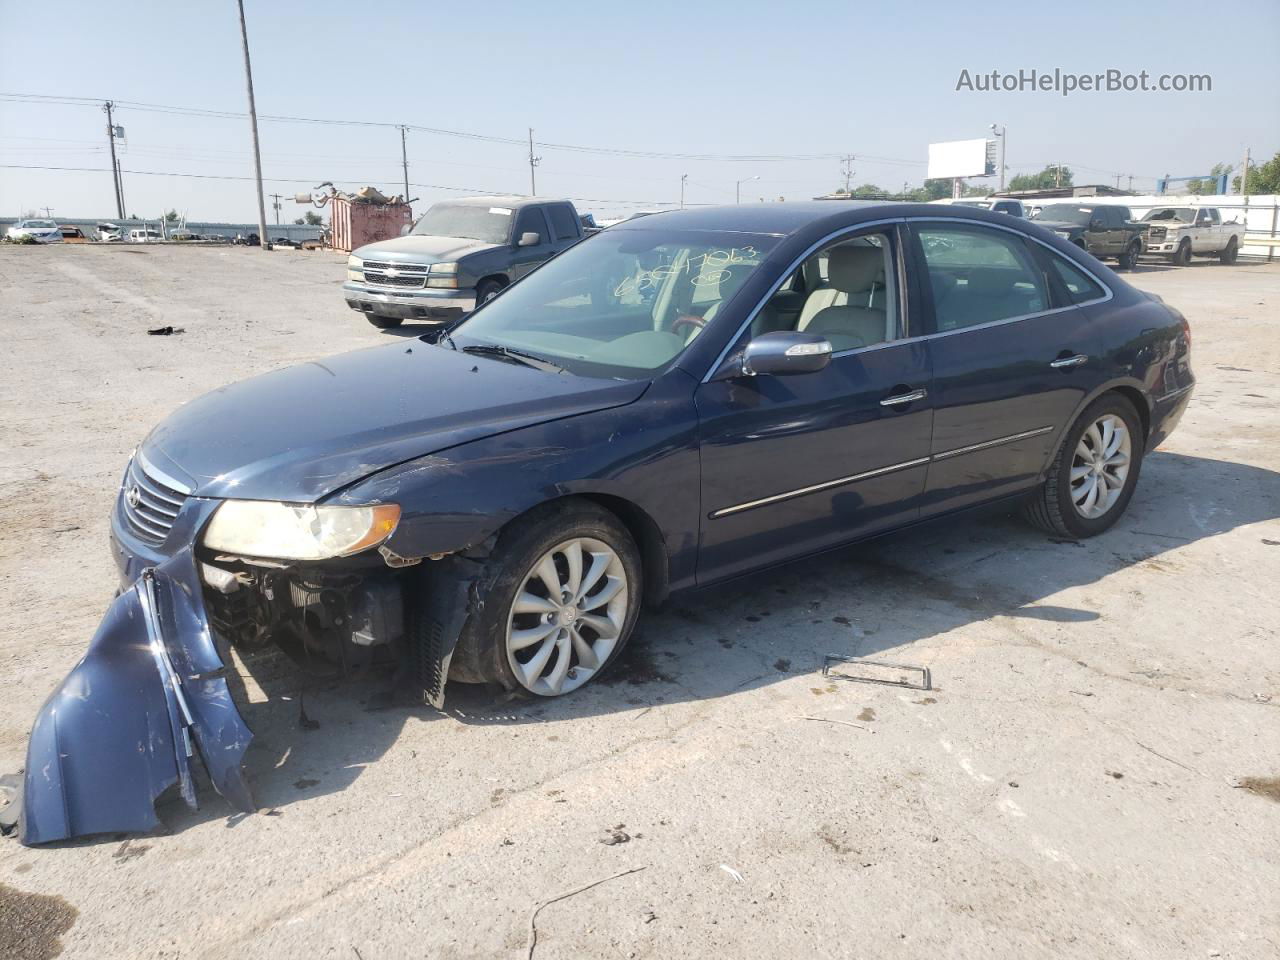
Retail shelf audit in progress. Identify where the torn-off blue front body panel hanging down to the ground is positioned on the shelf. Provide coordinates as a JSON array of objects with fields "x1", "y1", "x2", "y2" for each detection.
[{"x1": 19, "y1": 548, "x2": 255, "y2": 845}]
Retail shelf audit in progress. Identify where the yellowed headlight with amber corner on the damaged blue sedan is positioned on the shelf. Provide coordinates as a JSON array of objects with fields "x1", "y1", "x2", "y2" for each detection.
[{"x1": 205, "y1": 500, "x2": 399, "y2": 559}]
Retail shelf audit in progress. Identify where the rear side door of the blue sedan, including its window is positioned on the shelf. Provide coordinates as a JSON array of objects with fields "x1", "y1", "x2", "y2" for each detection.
[{"x1": 913, "y1": 223, "x2": 1102, "y2": 516}]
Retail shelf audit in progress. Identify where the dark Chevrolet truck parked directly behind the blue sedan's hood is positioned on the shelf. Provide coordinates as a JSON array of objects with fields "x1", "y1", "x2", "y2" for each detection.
[{"x1": 342, "y1": 197, "x2": 584, "y2": 328}]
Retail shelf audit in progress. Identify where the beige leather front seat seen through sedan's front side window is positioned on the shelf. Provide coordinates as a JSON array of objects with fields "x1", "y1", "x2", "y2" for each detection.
[{"x1": 796, "y1": 246, "x2": 890, "y2": 351}]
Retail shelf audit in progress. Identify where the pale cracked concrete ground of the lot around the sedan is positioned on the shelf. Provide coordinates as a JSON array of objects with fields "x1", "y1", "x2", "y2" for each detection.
[{"x1": 0, "y1": 246, "x2": 1280, "y2": 960}]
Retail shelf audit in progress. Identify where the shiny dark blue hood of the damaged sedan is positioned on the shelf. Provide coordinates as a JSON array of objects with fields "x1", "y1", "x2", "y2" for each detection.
[{"x1": 141, "y1": 339, "x2": 649, "y2": 503}]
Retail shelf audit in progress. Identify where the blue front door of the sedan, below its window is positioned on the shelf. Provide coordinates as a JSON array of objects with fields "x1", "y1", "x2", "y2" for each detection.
[{"x1": 695, "y1": 340, "x2": 933, "y2": 584}]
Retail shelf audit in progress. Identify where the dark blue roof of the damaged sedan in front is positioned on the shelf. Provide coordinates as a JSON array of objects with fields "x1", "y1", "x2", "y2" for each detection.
[{"x1": 609, "y1": 200, "x2": 1018, "y2": 237}]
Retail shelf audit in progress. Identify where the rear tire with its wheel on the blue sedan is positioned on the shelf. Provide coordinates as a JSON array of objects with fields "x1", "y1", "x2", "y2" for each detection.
[{"x1": 1024, "y1": 393, "x2": 1146, "y2": 540}]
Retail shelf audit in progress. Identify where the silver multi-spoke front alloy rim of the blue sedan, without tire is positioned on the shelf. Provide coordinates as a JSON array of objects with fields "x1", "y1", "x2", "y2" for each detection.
[{"x1": 506, "y1": 536, "x2": 628, "y2": 696}]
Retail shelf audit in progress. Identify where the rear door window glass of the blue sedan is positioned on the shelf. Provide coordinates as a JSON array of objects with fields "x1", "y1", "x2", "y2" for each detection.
[{"x1": 915, "y1": 223, "x2": 1050, "y2": 333}]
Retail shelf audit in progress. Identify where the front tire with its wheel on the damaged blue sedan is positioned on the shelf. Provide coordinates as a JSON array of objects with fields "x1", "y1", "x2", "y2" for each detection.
[{"x1": 451, "y1": 499, "x2": 644, "y2": 698}]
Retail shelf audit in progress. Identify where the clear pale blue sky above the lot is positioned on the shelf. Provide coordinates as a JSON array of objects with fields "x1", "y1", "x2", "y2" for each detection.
[{"x1": 0, "y1": 0, "x2": 1280, "y2": 221}]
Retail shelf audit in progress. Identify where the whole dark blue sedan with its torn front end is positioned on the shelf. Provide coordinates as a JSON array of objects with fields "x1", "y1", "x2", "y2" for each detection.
[{"x1": 23, "y1": 202, "x2": 1194, "y2": 842}]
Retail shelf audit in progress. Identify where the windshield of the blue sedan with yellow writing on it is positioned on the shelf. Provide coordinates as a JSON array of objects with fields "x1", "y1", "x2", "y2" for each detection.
[{"x1": 445, "y1": 228, "x2": 778, "y2": 379}]
